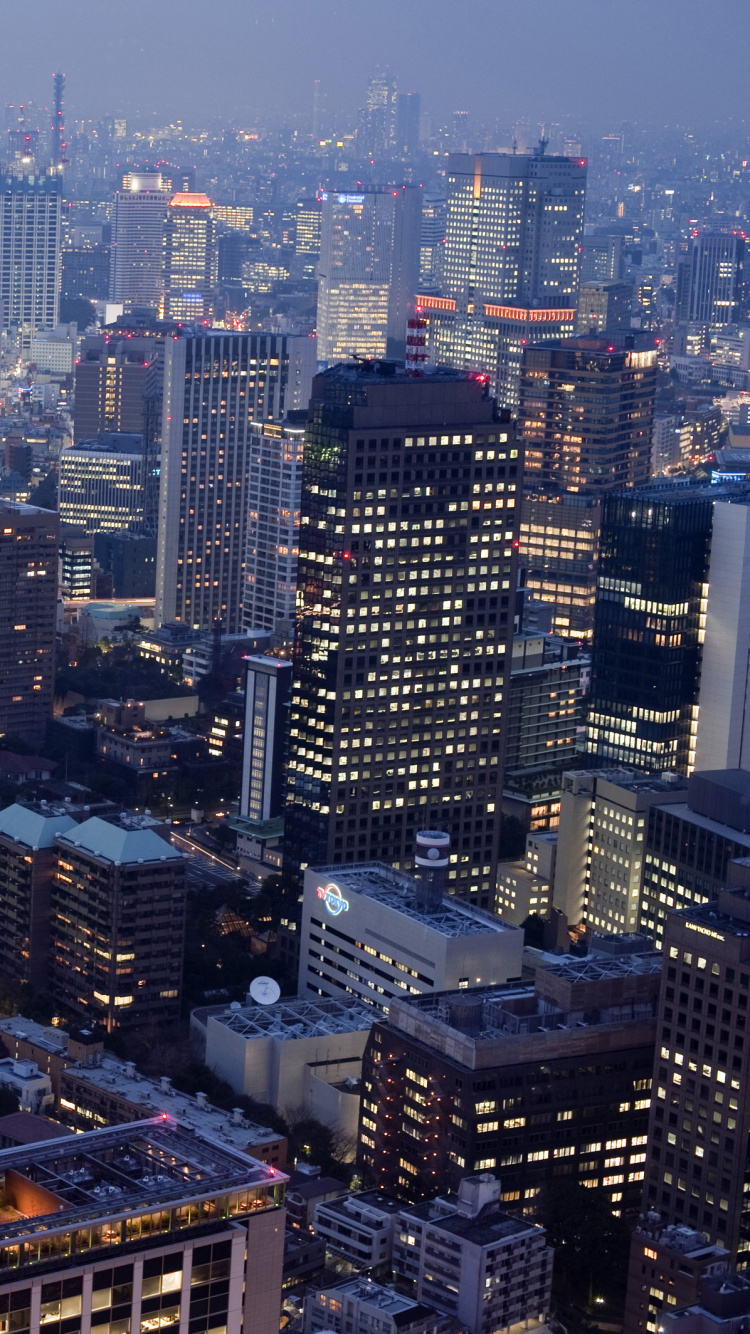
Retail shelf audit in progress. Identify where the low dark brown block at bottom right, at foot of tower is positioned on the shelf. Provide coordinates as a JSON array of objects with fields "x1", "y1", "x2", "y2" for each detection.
[{"x1": 623, "y1": 1210, "x2": 730, "y2": 1334}]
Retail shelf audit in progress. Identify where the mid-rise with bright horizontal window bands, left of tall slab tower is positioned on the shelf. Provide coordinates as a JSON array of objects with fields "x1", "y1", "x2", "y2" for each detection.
[{"x1": 59, "y1": 431, "x2": 144, "y2": 534}]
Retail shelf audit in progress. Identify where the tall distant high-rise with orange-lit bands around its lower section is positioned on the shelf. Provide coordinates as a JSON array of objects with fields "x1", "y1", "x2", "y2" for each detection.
[{"x1": 432, "y1": 151, "x2": 586, "y2": 410}]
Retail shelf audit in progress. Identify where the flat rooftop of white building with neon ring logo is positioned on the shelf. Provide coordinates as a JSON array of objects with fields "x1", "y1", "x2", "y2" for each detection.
[{"x1": 310, "y1": 862, "x2": 520, "y2": 938}]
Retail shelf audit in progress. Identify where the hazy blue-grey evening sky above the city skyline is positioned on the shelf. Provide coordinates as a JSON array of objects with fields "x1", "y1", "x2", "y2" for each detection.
[{"x1": 0, "y1": 0, "x2": 750, "y2": 124}]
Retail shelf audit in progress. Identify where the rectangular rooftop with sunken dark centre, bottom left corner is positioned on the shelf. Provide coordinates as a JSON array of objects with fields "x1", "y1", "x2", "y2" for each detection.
[{"x1": 0, "y1": 1113, "x2": 287, "y2": 1248}]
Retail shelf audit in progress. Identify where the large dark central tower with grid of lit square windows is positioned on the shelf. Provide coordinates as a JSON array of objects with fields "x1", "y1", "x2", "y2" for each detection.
[{"x1": 284, "y1": 366, "x2": 522, "y2": 904}]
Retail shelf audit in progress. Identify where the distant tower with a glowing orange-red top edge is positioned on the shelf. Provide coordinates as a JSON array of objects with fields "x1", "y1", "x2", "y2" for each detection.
[{"x1": 161, "y1": 193, "x2": 216, "y2": 324}]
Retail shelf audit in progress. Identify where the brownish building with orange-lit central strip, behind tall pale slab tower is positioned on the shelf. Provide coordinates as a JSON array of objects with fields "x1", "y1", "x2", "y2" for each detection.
[{"x1": 73, "y1": 338, "x2": 153, "y2": 440}]
